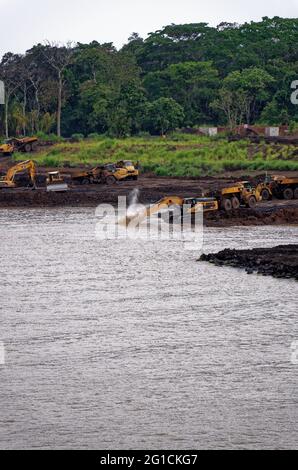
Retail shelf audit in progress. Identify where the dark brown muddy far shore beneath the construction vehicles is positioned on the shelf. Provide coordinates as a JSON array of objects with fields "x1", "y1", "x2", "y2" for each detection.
[{"x1": 0, "y1": 175, "x2": 298, "y2": 227}]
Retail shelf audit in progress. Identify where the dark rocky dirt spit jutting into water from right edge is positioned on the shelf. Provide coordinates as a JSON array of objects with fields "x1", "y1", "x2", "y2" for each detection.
[{"x1": 200, "y1": 245, "x2": 298, "y2": 281}]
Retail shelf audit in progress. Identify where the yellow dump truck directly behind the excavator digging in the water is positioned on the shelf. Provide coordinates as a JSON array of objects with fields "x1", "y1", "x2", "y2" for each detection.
[{"x1": 206, "y1": 181, "x2": 261, "y2": 212}]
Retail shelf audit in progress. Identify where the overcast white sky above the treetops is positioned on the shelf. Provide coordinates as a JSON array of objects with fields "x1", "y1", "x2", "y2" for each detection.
[{"x1": 0, "y1": 0, "x2": 298, "y2": 57}]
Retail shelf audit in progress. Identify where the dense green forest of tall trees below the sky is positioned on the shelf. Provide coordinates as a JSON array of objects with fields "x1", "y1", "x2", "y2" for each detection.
[{"x1": 0, "y1": 17, "x2": 298, "y2": 137}]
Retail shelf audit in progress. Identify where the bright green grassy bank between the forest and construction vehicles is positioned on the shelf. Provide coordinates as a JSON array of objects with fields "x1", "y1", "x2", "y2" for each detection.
[{"x1": 15, "y1": 134, "x2": 298, "y2": 176}]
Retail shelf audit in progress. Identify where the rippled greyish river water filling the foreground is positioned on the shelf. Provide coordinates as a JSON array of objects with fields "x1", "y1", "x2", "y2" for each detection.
[{"x1": 0, "y1": 208, "x2": 298, "y2": 449}]
